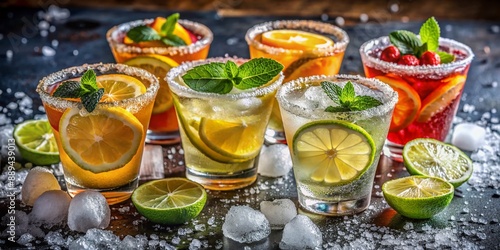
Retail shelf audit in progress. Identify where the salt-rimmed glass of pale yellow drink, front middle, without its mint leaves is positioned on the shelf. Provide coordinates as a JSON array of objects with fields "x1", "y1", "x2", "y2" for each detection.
[{"x1": 166, "y1": 58, "x2": 283, "y2": 190}]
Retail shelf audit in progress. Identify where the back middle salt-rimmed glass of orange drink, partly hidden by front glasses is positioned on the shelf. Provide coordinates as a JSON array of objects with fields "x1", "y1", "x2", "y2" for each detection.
[{"x1": 245, "y1": 20, "x2": 349, "y2": 143}]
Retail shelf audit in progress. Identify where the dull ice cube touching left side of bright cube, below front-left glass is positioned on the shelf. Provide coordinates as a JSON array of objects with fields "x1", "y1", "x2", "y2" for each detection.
[{"x1": 29, "y1": 190, "x2": 71, "y2": 225}]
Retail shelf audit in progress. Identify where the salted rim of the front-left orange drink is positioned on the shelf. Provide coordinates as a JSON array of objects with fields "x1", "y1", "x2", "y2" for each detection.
[{"x1": 36, "y1": 63, "x2": 160, "y2": 113}]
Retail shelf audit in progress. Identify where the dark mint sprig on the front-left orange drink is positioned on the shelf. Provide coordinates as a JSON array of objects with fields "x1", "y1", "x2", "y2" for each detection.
[{"x1": 52, "y1": 69, "x2": 104, "y2": 112}]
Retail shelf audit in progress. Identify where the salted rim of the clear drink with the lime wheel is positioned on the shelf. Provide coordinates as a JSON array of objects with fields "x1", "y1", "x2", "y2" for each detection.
[{"x1": 276, "y1": 74, "x2": 398, "y2": 119}]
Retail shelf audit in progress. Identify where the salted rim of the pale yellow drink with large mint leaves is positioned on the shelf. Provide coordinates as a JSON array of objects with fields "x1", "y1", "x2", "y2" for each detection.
[{"x1": 165, "y1": 57, "x2": 285, "y2": 100}]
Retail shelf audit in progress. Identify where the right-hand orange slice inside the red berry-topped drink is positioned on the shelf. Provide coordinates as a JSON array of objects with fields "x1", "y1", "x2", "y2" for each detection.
[{"x1": 417, "y1": 75, "x2": 465, "y2": 122}]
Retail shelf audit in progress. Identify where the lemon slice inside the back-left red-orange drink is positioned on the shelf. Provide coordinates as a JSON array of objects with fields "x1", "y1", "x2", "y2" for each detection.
[{"x1": 124, "y1": 55, "x2": 179, "y2": 114}]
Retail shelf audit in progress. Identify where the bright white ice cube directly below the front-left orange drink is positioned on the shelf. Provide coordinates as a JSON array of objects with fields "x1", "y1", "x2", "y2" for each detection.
[{"x1": 68, "y1": 191, "x2": 111, "y2": 232}]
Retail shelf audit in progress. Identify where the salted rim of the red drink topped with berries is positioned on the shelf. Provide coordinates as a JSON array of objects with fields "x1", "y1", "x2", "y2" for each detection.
[{"x1": 359, "y1": 36, "x2": 474, "y2": 79}]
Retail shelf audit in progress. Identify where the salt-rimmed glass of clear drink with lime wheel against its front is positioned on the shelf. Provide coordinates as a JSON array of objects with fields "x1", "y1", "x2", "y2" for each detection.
[{"x1": 276, "y1": 75, "x2": 397, "y2": 215}]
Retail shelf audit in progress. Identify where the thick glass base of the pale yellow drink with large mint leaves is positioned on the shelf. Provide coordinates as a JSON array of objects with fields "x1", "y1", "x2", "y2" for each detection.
[{"x1": 186, "y1": 167, "x2": 257, "y2": 190}]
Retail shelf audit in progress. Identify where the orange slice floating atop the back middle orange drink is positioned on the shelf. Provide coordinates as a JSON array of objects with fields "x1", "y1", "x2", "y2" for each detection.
[{"x1": 262, "y1": 30, "x2": 333, "y2": 50}]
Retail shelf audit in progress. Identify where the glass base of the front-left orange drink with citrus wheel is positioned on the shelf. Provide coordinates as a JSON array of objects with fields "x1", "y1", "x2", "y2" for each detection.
[{"x1": 65, "y1": 177, "x2": 139, "y2": 205}]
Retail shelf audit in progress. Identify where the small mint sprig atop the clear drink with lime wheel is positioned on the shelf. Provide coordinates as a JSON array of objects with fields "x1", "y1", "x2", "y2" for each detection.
[{"x1": 321, "y1": 81, "x2": 382, "y2": 113}]
